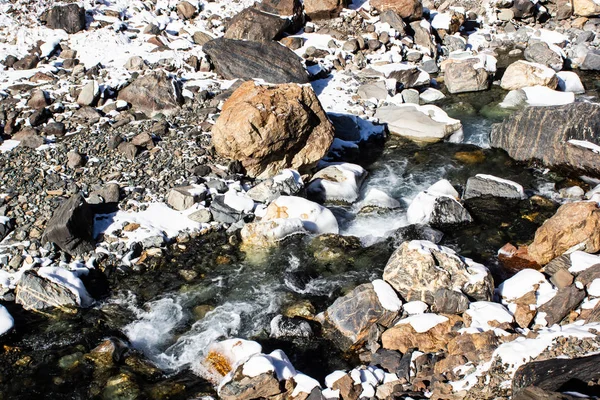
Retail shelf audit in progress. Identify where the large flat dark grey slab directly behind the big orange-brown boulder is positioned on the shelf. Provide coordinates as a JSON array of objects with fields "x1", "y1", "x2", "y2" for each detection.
[{"x1": 203, "y1": 38, "x2": 308, "y2": 83}]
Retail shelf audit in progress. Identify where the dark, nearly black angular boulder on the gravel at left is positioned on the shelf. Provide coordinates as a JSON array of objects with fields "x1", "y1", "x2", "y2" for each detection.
[{"x1": 42, "y1": 194, "x2": 94, "y2": 255}]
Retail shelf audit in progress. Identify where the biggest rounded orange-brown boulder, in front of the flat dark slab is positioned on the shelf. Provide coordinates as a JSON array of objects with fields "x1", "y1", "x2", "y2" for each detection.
[{"x1": 212, "y1": 82, "x2": 334, "y2": 178}]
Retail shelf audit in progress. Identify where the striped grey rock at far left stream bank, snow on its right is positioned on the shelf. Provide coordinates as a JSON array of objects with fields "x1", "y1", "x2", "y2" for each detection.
[{"x1": 15, "y1": 271, "x2": 79, "y2": 312}]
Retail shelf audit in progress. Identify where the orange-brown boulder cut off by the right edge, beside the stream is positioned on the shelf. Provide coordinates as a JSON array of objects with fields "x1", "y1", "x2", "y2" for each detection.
[{"x1": 529, "y1": 202, "x2": 600, "y2": 265}]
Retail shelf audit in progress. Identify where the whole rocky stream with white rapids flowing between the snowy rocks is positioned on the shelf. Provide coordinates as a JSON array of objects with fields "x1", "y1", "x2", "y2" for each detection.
[{"x1": 0, "y1": 91, "x2": 584, "y2": 399}]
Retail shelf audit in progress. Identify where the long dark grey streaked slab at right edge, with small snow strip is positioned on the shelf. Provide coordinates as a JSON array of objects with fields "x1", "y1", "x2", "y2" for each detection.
[{"x1": 490, "y1": 102, "x2": 600, "y2": 176}]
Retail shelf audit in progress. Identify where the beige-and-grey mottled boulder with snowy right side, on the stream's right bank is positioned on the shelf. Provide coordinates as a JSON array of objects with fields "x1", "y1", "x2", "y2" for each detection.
[{"x1": 383, "y1": 240, "x2": 494, "y2": 305}]
